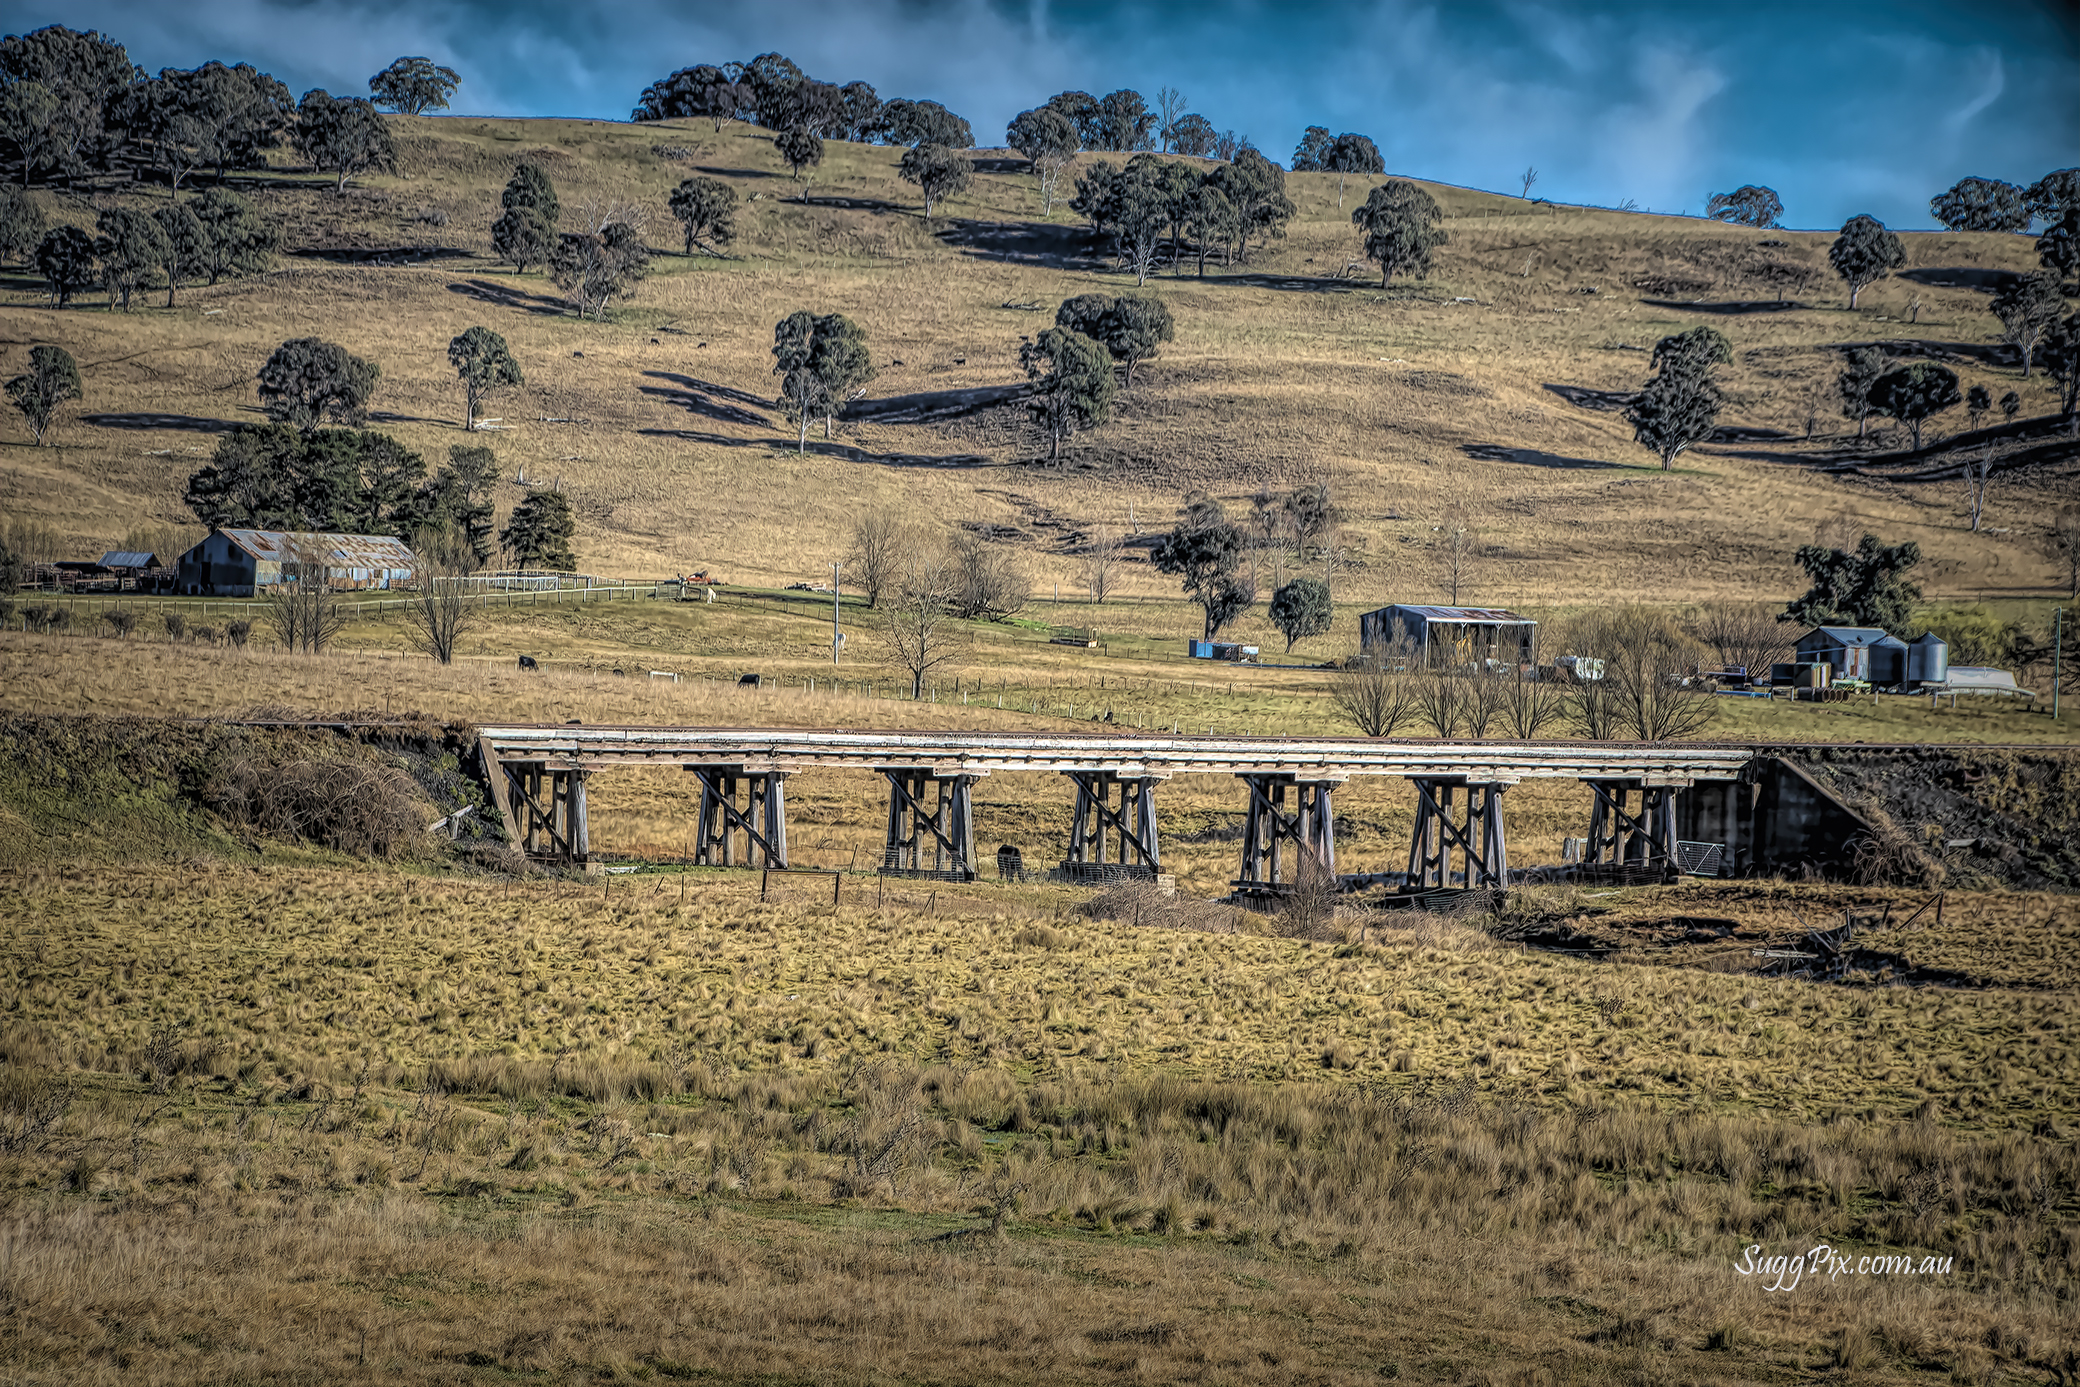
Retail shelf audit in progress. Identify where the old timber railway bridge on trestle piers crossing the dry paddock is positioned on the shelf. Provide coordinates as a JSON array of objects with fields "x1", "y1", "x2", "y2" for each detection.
[{"x1": 480, "y1": 724, "x2": 1857, "y2": 892}]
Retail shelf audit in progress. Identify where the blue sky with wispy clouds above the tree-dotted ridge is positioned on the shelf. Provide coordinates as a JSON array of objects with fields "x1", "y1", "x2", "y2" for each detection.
[{"x1": 16, "y1": 0, "x2": 2080, "y2": 229}]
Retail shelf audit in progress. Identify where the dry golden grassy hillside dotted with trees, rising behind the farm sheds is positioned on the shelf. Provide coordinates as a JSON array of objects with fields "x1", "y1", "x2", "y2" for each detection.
[{"x1": 0, "y1": 119, "x2": 2072, "y2": 623}]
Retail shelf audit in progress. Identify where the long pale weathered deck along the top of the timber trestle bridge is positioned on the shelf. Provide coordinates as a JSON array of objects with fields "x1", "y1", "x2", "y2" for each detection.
[{"x1": 478, "y1": 724, "x2": 1760, "y2": 782}]
